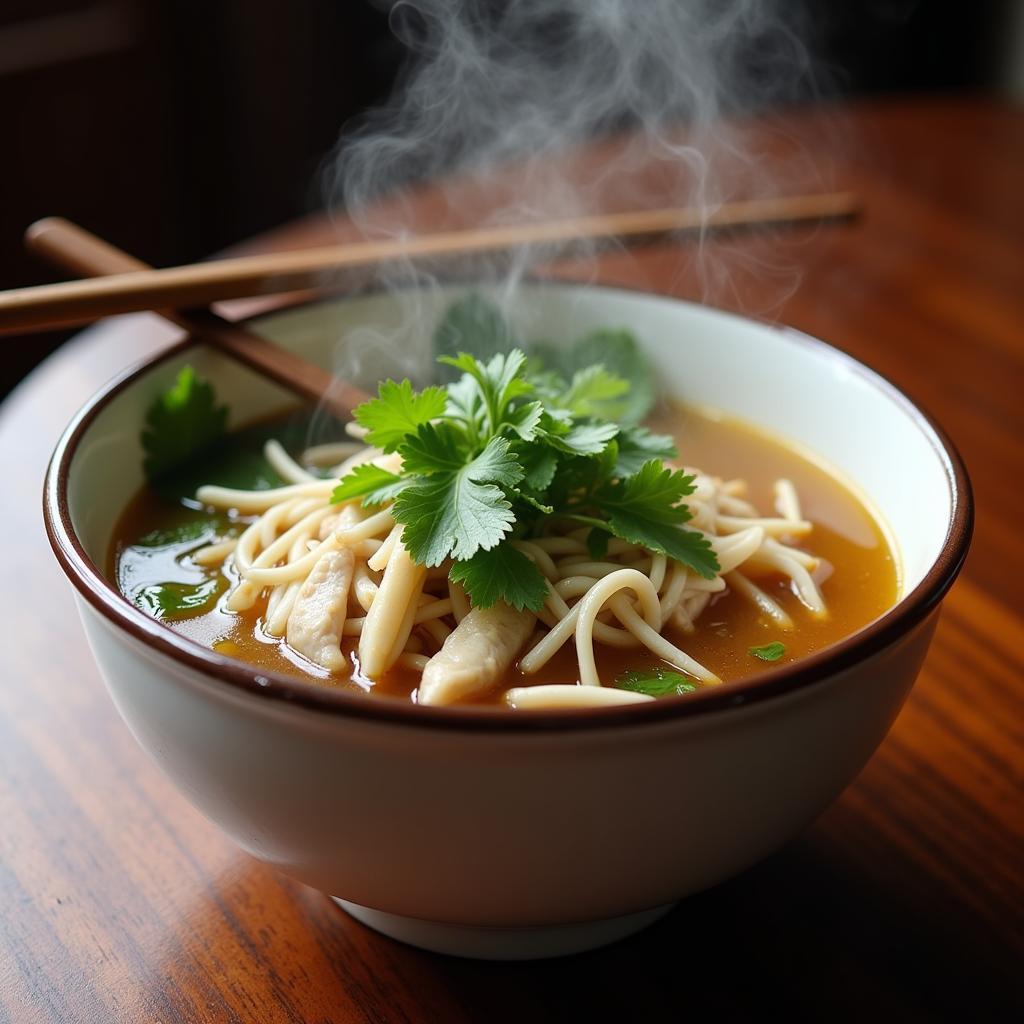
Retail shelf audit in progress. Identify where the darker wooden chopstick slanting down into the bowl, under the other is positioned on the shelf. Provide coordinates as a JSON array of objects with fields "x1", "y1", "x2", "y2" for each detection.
[{"x1": 26, "y1": 217, "x2": 368, "y2": 419}]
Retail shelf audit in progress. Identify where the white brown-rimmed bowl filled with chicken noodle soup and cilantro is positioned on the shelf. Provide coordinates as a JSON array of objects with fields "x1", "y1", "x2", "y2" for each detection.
[{"x1": 44, "y1": 284, "x2": 972, "y2": 958}]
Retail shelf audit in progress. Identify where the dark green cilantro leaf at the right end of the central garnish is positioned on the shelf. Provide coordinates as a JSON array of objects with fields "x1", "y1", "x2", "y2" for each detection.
[{"x1": 593, "y1": 459, "x2": 719, "y2": 580}]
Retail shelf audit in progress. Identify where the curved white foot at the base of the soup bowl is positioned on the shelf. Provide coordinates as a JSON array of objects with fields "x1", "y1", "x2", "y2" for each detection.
[{"x1": 332, "y1": 896, "x2": 676, "y2": 961}]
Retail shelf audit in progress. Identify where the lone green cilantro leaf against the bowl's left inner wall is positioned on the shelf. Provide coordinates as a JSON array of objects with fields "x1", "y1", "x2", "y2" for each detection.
[{"x1": 142, "y1": 366, "x2": 227, "y2": 480}]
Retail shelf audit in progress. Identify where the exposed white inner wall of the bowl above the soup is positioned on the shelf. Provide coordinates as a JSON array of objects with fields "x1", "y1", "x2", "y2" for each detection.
[{"x1": 69, "y1": 285, "x2": 954, "y2": 594}]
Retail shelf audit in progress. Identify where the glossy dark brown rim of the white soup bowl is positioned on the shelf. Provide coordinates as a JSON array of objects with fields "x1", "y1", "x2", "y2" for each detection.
[{"x1": 43, "y1": 281, "x2": 974, "y2": 733}]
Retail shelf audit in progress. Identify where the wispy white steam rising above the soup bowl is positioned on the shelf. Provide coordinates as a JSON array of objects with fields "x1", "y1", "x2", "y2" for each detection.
[{"x1": 315, "y1": 0, "x2": 812, "y2": 395}]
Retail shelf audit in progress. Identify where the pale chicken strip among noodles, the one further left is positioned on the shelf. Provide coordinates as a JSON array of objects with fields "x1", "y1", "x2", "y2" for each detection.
[{"x1": 287, "y1": 548, "x2": 355, "y2": 672}]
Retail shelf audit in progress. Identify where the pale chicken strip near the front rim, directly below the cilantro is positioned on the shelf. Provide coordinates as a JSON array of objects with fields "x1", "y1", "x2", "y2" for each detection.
[{"x1": 419, "y1": 601, "x2": 537, "y2": 705}]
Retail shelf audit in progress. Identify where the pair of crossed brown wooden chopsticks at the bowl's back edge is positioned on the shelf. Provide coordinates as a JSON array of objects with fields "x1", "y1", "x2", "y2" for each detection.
[{"x1": 8, "y1": 193, "x2": 858, "y2": 416}]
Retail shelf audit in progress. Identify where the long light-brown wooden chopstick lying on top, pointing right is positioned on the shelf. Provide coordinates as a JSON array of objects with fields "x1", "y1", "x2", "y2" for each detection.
[{"x1": 0, "y1": 193, "x2": 858, "y2": 334}]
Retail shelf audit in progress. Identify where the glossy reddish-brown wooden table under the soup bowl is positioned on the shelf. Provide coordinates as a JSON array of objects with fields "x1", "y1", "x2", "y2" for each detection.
[{"x1": 0, "y1": 101, "x2": 1024, "y2": 1024}]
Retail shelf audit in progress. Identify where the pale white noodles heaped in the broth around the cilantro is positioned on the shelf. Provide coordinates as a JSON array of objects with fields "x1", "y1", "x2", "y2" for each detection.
[{"x1": 190, "y1": 440, "x2": 827, "y2": 709}]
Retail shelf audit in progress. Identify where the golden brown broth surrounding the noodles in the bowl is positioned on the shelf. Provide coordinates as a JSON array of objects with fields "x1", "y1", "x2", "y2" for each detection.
[{"x1": 110, "y1": 407, "x2": 899, "y2": 703}]
